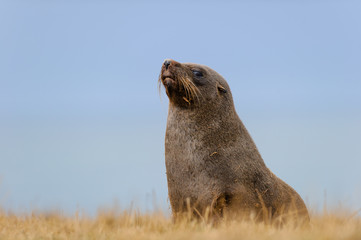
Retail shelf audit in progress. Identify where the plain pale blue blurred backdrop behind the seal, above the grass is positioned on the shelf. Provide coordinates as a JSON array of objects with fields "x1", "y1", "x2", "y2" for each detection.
[{"x1": 0, "y1": 0, "x2": 361, "y2": 214}]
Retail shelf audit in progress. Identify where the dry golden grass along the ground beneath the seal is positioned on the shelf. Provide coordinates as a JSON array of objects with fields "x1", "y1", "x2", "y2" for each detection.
[{"x1": 0, "y1": 207, "x2": 361, "y2": 240}]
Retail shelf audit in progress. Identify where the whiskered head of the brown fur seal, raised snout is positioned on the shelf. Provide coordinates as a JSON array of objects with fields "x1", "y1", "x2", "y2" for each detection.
[{"x1": 159, "y1": 59, "x2": 233, "y2": 108}]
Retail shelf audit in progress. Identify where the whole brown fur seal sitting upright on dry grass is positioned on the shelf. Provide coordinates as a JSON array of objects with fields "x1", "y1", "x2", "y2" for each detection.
[{"x1": 159, "y1": 59, "x2": 309, "y2": 222}]
